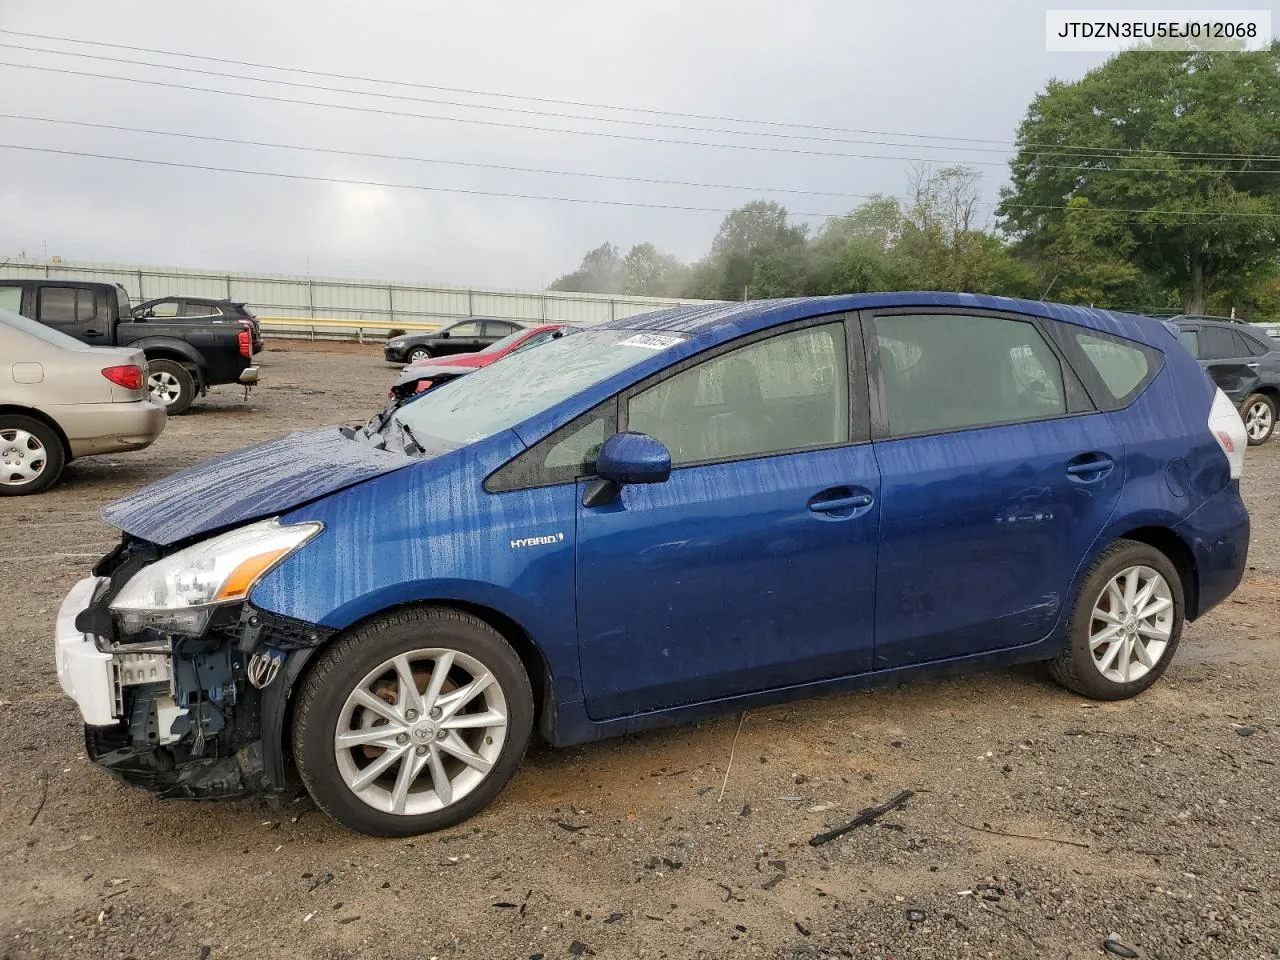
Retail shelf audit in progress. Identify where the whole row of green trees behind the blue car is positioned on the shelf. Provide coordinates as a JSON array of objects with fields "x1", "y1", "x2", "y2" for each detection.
[{"x1": 552, "y1": 44, "x2": 1280, "y2": 319}]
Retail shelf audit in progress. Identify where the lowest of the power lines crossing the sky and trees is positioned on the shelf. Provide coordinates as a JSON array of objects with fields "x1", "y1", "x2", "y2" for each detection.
[{"x1": 0, "y1": 143, "x2": 1280, "y2": 220}]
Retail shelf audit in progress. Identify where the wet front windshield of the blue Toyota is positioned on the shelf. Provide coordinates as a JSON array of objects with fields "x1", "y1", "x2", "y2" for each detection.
[{"x1": 389, "y1": 330, "x2": 685, "y2": 445}]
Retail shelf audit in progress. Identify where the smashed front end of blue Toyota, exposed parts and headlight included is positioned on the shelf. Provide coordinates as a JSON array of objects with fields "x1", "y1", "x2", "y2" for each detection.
[{"x1": 56, "y1": 520, "x2": 333, "y2": 799}]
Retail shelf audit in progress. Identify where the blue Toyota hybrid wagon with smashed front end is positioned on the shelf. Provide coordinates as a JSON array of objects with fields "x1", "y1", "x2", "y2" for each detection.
[{"x1": 56, "y1": 293, "x2": 1249, "y2": 835}]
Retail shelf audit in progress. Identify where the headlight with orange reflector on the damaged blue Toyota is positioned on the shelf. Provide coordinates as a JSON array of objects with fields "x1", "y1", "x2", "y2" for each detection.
[{"x1": 111, "y1": 518, "x2": 324, "y2": 635}]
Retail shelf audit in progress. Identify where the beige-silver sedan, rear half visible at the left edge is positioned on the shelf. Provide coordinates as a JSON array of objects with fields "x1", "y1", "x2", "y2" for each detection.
[{"x1": 0, "y1": 310, "x2": 165, "y2": 497}]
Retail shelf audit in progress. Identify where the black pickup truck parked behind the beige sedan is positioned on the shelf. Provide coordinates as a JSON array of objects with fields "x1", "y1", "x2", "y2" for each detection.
[{"x1": 0, "y1": 279, "x2": 257, "y2": 416}]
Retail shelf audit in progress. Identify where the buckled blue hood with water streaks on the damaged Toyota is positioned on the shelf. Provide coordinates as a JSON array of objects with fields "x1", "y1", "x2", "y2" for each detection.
[{"x1": 102, "y1": 426, "x2": 416, "y2": 545}]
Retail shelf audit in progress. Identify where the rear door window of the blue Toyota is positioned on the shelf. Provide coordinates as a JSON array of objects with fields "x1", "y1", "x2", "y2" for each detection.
[{"x1": 873, "y1": 314, "x2": 1078, "y2": 436}]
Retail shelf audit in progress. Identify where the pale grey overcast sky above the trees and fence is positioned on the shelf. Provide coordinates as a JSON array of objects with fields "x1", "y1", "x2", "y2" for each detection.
[{"x1": 0, "y1": 0, "x2": 1259, "y2": 288}]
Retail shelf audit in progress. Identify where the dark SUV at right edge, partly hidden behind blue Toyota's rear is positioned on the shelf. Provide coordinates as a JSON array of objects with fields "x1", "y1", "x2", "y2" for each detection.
[{"x1": 1170, "y1": 316, "x2": 1280, "y2": 447}]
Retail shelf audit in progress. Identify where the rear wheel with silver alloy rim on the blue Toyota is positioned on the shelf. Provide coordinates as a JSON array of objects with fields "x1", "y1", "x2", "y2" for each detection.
[{"x1": 1048, "y1": 540, "x2": 1183, "y2": 700}]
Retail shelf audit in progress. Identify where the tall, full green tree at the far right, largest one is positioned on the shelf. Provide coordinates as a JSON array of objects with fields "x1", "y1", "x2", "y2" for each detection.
[{"x1": 998, "y1": 44, "x2": 1280, "y2": 312}]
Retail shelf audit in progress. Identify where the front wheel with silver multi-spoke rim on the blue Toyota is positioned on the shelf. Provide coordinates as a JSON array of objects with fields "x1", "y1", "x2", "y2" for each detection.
[{"x1": 293, "y1": 608, "x2": 534, "y2": 837}]
